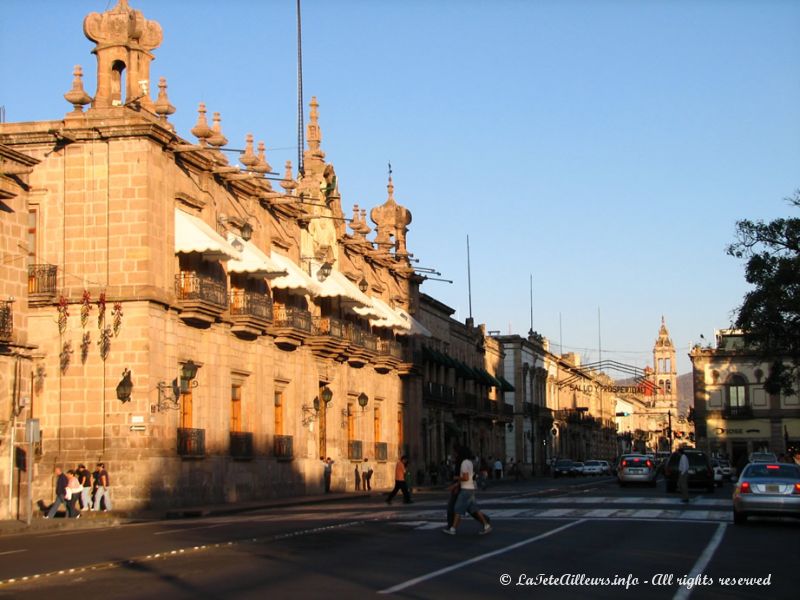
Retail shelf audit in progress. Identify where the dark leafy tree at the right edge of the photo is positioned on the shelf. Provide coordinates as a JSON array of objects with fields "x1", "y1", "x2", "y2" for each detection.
[{"x1": 727, "y1": 190, "x2": 800, "y2": 394}]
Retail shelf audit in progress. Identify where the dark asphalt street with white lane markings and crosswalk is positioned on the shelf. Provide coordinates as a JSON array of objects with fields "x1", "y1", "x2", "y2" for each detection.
[{"x1": 0, "y1": 477, "x2": 800, "y2": 598}]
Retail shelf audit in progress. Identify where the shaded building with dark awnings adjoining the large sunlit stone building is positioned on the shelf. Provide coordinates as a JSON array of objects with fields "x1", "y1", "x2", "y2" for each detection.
[{"x1": 418, "y1": 294, "x2": 513, "y2": 472}]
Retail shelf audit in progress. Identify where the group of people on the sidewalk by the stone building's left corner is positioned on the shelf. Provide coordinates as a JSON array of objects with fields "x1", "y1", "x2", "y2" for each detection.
[{"x1": 44, "y1": 463, "x2": 111, "y2": 519}]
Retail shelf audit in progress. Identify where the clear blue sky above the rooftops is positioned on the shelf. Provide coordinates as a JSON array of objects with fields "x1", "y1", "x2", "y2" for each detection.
[{"x1": 0, "y1": 0, "x2": 800, "y2": 375}]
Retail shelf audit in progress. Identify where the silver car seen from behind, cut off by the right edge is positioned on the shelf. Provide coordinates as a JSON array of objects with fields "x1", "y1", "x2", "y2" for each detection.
[{"x1": 733, "y1": 462, "x2": 800, "y2": 525}]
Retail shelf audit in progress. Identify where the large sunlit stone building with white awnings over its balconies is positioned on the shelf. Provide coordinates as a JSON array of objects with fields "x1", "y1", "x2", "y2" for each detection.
[{"x1": 0, "y1": 0, "x2": 432, "y2": 510}]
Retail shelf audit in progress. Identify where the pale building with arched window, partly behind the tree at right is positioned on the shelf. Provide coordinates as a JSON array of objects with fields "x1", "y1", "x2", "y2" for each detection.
[{"x1": 689, "y1": 330, "x2": 800, "y2": 464}]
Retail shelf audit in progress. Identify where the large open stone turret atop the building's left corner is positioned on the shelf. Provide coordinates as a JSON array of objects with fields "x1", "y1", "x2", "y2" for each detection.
[{"x1": 83, "y1": 0, "x2": 163, "y2": 111}]
